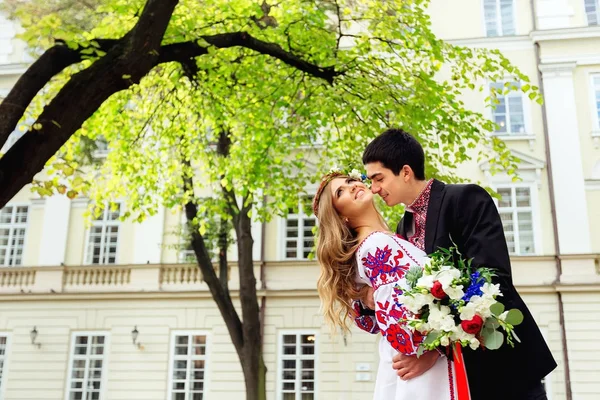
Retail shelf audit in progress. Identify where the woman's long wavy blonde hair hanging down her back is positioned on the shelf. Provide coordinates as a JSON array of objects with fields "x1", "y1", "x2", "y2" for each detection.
[{"x1": 315, "y1": 175, "x2": 387, "y2": 332}]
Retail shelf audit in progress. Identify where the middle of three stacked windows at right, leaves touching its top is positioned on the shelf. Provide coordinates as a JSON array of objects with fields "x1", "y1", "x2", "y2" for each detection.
[{"x1": 490, "y1": 82, "x2": 527, "y2": 135}]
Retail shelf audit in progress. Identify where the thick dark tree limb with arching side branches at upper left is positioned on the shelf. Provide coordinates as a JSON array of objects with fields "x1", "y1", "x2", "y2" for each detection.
[{"x1": 0, "y1": 0, "x2": 342, "y2": 207}]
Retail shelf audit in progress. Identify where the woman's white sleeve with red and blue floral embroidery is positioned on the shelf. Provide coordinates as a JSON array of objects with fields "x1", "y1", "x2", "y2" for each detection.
[{"x1": 358, "y1": 232, "x2": 423, "y2": 355}]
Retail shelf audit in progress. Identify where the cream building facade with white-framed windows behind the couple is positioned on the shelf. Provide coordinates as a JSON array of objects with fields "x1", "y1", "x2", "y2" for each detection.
[{"x1": 0, "y1": 0, "x2": 600, "y2": 400}]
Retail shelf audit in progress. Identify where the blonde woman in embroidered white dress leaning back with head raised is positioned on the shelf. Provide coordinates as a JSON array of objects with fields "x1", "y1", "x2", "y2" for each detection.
[{"x1": 313, "y1": 172, "x2": 455, "y2": 400}]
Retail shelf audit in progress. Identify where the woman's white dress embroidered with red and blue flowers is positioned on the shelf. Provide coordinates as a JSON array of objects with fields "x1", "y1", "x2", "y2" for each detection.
[{"x1": 355, "y1": 232, "x2": 455, "y2": 400}]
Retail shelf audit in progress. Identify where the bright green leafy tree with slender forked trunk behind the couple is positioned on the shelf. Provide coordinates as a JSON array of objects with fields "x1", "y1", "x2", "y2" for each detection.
[{"x1": 0, "y1": 0, "x2": 537, "y2": 399}]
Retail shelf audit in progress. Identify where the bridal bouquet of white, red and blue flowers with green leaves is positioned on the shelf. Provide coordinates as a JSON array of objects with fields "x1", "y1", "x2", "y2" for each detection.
[{"x1": 398, "y1": 248, "x2": 523, "y2": 354}]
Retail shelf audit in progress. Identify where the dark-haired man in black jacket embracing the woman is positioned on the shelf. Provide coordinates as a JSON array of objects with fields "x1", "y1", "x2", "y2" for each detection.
[{"x1": 363, "y1": 129, "x2": 556, "y2": 400}]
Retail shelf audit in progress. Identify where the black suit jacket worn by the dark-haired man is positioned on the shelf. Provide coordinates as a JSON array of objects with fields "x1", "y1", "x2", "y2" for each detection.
[{"x1": 397, "y1": 180, "x2": 556, "y2": 400}]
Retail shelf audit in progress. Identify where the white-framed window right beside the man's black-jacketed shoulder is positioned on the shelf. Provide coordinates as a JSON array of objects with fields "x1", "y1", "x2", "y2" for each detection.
[{"x1": 496, "y1": 186, "x2": 535, "y2": 255}]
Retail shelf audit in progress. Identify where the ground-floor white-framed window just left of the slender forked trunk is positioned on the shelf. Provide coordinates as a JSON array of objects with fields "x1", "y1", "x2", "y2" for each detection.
[{"x1": 169, "y1": 334, "x2": 207, "y2": 400}]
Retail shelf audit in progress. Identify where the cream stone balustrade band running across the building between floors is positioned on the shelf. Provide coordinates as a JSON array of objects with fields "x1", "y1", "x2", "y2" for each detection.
[{"x1": 0, "y1": 254, "x2": 600, "y2": 295}]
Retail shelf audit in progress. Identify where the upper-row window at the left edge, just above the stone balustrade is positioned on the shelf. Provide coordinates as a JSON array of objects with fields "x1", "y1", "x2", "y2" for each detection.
[{"x1": 0, "y1": 206, "x2": 29, "y2": 266}]
